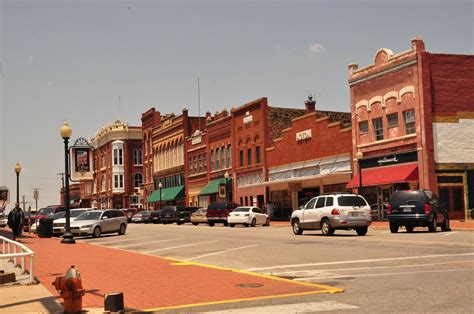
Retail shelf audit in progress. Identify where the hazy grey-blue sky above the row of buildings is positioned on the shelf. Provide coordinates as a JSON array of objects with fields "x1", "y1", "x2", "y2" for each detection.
[{"x1": 0, "y1": 0, "x2": 474, "y2": 211}]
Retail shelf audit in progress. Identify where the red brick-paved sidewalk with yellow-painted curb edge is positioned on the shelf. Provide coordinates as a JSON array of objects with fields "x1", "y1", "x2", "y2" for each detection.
[{"x1": 0, "y1": 231, "x2": 342, "y2": 310}]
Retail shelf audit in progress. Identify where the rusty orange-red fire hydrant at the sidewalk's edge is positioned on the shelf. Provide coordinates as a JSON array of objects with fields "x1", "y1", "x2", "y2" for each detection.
[{"x1": 52, "y1": 265, "x2": 85, "y2": 313}]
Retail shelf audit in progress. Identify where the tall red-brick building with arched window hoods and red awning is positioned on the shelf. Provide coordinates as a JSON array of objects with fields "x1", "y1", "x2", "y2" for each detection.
[{"x1": 348, "y1": 38, "x2": 474, "y2": 219}]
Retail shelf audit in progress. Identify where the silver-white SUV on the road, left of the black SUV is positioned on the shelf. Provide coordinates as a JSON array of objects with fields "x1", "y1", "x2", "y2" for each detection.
[{"x1": 291, "y1": 194, "x2": 372, "y2": 236}]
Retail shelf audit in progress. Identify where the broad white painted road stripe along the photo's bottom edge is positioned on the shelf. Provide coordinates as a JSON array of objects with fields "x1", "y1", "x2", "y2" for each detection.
[{"x1": 205, "y1": 301, "x2": 359, "y2": 314}]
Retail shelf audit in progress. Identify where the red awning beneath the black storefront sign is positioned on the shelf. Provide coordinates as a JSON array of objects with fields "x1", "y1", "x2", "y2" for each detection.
[{"x1": 346, "y1": 164, "x2": 418, "y2": 188}]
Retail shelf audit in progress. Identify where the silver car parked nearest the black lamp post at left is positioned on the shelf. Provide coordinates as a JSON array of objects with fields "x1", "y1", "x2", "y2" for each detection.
[{"x1": 71, "y1": 209, "x2": 127, "y2": 238}]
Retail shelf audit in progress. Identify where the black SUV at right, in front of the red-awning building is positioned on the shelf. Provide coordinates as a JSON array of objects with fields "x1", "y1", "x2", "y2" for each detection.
[{"x1": 387, "y1": 190, "x2": 451, "y2": 233}]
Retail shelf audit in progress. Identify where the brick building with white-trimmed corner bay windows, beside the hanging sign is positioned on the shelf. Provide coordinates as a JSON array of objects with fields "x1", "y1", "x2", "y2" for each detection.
[{"x1": 91, "y1": 120, "x2": 143, "y2": 208}]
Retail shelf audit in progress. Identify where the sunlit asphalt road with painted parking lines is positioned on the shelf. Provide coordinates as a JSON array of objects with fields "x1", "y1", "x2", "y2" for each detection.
[{"x1": 80, "y1": 224, "x2": 474, "y2": 313}]
